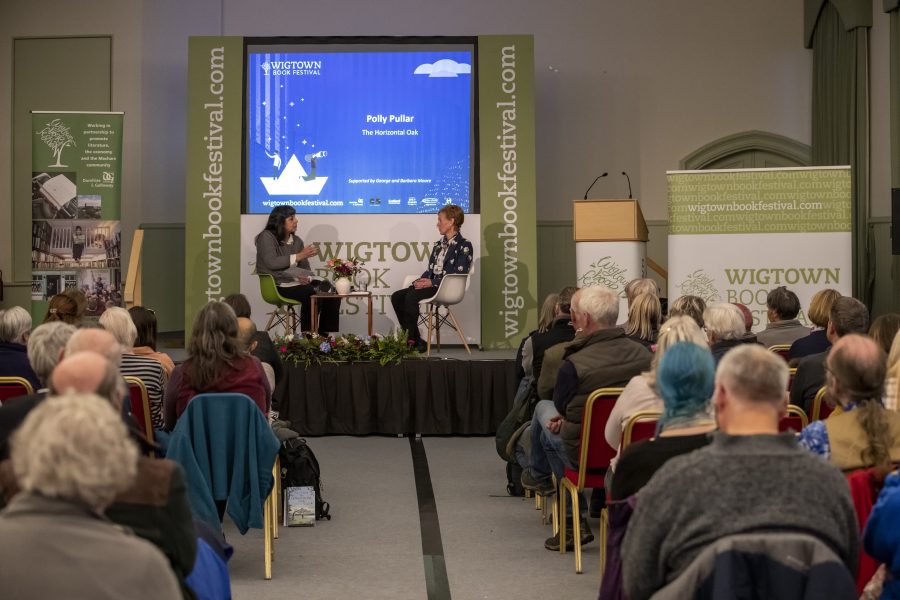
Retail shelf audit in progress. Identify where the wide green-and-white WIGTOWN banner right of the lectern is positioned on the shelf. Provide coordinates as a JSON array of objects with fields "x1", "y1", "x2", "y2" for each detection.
[{"x1": 668, "y1": 167, "x2": 853, "y2": 331}]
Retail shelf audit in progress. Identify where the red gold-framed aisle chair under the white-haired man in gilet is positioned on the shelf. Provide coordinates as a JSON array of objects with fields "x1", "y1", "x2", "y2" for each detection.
[{"x1": 557, "y1": 388, "x2": 624, "y2": 573}]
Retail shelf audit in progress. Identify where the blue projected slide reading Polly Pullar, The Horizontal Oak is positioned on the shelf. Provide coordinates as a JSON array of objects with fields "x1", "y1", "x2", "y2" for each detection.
[{"x1": 246, "y1": 51, "x2": 473, "y2": 214}]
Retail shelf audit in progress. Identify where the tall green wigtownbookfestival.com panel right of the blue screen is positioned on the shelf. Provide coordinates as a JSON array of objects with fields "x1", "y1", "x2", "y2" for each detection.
[{"x1": 478, "y1": 35, "x2": 537, "y2": 348}]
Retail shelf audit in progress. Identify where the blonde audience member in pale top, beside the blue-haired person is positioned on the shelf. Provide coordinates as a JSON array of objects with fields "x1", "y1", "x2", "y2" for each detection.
[{"x1": 604, "y1": 316, "x2": 706, "y2": 465}]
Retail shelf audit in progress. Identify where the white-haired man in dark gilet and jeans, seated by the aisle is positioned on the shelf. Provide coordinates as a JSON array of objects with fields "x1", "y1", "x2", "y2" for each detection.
[{"x1": 522, "y1": 287, "x2": 652, "y2": 550}]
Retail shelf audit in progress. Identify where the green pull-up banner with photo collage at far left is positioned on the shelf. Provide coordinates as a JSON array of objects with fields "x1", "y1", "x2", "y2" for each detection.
[{"x1": 31, "y1": 112, "x2": 123, "y2": 322}]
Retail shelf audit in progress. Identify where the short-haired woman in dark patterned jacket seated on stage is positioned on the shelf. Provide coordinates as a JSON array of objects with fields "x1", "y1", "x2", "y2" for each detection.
[{"x1": 391, "y1": 204, "x2": 472, "y2": 350}]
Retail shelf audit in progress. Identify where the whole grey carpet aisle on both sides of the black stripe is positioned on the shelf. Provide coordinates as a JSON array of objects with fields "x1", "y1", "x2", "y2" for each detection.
[{"x1": 226, "y1": 437, "x2": 599, "y2": 600}]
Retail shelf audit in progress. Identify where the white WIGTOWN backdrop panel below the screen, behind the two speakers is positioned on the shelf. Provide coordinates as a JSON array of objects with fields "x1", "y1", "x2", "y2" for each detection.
[{"x1": 241, "y1": 214, "x2": 481, "y2": 344}]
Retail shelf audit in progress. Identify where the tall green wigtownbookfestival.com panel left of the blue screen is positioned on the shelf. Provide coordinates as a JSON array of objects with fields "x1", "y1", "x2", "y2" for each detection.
[{"x1": 184, "y1": 37, "x2": 244, "y2": 334}]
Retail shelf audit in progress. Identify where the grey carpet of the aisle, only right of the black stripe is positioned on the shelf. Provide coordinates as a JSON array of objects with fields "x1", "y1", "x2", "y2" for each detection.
[{"x1": 425, "y1": 438, "x2": 600, "y2": 600}]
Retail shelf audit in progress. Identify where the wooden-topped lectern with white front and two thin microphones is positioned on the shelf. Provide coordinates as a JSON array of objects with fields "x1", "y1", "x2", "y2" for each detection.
[{"x1": 573, "y1": 198, "x2": 648, "y2": 308}]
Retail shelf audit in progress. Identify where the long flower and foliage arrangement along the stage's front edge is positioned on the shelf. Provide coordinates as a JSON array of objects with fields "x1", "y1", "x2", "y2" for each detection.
[{"x1": 275, "y1": 331, "x2": 419, "y2": 368}]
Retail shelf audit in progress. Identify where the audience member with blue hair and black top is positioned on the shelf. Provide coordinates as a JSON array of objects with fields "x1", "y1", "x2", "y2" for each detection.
[{"x1": 610, "y1": 342, "x2": 716, "y2": 500}]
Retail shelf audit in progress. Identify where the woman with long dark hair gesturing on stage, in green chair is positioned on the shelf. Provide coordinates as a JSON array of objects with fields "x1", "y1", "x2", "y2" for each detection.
[{"x1": 255, "y1": 206, "x2": 341, "y2": 334}]
